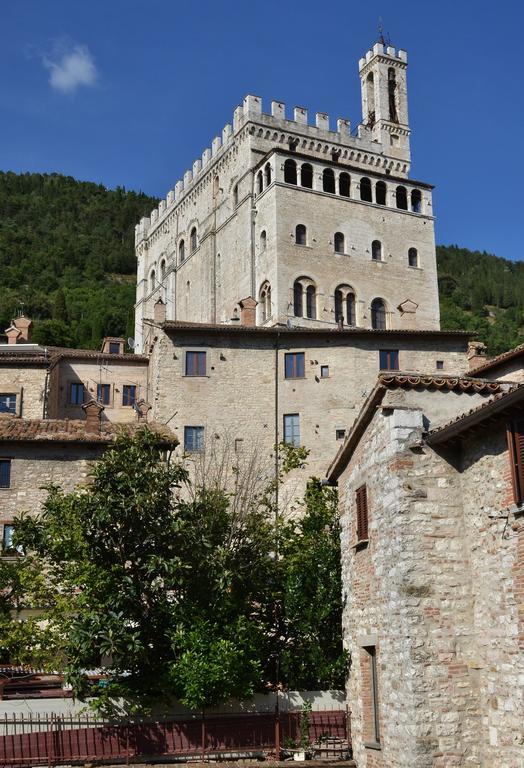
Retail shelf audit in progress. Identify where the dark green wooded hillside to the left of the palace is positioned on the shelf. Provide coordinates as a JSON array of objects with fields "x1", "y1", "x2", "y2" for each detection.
[{"x1": 0, "y1": 173, "x2": 157, "y2": 348}]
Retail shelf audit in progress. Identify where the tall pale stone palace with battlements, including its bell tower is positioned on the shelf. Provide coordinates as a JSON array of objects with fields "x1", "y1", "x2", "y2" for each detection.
[{"x1": 135, "y1": 43, "x2": 439, "y2": 352}]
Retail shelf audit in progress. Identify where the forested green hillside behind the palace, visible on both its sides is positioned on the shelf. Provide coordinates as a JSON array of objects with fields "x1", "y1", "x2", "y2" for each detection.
[{"x1": 0, "y1": 173, "x2": 524, "y2": 354}]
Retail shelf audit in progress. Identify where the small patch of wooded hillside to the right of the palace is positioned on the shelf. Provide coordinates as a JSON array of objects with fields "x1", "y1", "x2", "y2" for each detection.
[{"x1": 437, "y1": 245, "x2": 524, "y2": 355}]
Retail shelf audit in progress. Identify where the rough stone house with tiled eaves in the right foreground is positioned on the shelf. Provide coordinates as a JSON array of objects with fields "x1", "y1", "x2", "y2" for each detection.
[{"x1": 327, "y1": 373, "x2": 524, "y2": 768}]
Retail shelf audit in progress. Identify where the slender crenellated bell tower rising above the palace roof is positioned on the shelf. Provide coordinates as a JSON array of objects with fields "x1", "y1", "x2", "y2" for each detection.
[{"x1": 359, "y1": 42, "x2": 410, "y2": 162}]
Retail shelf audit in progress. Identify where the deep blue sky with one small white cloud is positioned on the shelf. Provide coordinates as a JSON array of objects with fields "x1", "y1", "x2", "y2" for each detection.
[{"x1": 0, "y1": 0, "x2": 524, "y2": 259}]
